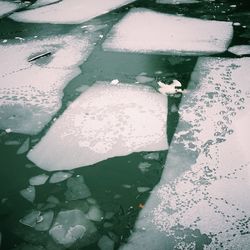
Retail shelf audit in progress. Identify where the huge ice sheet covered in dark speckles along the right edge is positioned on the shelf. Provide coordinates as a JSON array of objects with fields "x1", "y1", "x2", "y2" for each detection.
[{"x1": 122, "y1": 57, "x2": 250, "y2": 250}]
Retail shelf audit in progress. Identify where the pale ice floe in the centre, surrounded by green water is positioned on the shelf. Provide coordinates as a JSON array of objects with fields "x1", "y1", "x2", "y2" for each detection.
[{"x1": 28, "y1": 82, "x2": 168, "y2": 171}]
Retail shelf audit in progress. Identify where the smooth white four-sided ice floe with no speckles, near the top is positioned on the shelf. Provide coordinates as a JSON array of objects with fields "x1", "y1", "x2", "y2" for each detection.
[{"x1": 103, "y1": 8, "x2": 233, "y2": 55}]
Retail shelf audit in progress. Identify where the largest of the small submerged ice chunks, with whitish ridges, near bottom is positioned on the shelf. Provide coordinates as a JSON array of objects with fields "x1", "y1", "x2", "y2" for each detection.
[{"x1": 49, "y1": 209, "x2": 96, "y2": 247}]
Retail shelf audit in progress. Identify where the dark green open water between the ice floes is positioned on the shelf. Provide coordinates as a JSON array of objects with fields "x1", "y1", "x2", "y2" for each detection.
[{"x1": 0, "y1": 0, "x2": 250, "y2": 250}]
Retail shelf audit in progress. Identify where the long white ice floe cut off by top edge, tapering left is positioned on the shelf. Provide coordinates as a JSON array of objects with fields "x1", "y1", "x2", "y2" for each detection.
[{"x1": 11, "y1": 0, "x2": 133, "y2": 24}]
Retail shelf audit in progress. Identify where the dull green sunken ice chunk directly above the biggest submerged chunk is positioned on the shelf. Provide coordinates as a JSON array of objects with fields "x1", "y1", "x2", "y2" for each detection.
[{"x1": 65, "y1": 176, "x2": 91, "y2": 201}]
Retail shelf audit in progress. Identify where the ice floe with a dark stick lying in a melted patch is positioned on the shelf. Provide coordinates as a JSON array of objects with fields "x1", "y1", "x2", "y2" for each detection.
[{"x1": 0, "y1": 31, "x2": 99, "y2": 134}]
